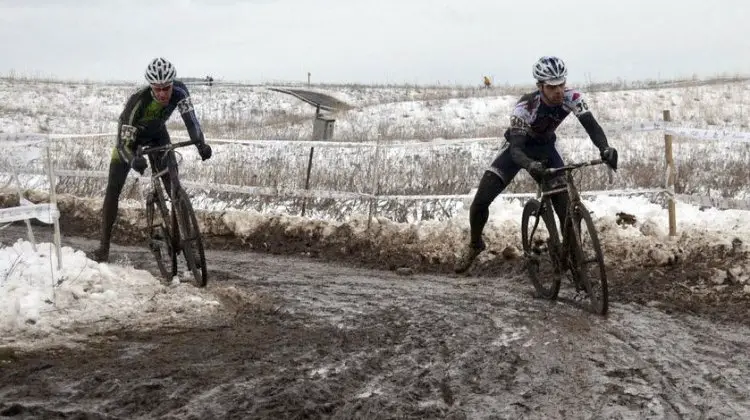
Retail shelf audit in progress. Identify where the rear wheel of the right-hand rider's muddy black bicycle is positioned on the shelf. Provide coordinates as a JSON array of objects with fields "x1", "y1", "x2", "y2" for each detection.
[{"x1": 521, "y1": 199, "x2": 561, "y2": 300}]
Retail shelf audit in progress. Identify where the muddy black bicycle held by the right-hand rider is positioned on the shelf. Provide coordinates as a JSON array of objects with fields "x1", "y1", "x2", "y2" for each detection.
[{"x1": 521, "y1": 159, "x2": 609, "y2": 315}]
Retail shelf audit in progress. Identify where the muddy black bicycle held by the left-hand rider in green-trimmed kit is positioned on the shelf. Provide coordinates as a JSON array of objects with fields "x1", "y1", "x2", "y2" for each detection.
[{"x1": 135, "y1": 141, "x2": 208, "y2": 287}]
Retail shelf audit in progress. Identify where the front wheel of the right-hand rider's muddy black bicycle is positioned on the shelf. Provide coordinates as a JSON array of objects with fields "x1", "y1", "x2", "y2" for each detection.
[{"x1": 571, "y1": 203, "x2": 609, "y2": 315}]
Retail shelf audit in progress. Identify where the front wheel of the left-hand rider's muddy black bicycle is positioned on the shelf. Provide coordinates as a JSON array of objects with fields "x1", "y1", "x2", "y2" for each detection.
[{"x1": 175, "y1": 187, "x2": 208, "y2": 287}]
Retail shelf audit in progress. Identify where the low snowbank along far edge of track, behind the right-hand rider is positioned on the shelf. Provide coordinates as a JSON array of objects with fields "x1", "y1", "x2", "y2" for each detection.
[{"x1": 210, "y1": 190, "x2": 750, "y2": 275}]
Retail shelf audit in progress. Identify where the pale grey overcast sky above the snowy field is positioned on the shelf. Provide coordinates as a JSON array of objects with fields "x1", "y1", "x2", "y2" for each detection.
[{"x1": 0, "y1": 0, "x2": 750, "y2": 84}]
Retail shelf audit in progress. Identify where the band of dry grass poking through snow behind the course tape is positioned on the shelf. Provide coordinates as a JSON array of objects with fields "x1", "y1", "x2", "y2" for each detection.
[{"x1": 5, "y1": 128, "x2": 750, "y2": 221}]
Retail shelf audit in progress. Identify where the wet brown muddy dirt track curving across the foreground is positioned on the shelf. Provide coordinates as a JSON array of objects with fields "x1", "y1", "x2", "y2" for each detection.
[{"x1": 0, "y1": 227, "x2": 750, "y2": 419}]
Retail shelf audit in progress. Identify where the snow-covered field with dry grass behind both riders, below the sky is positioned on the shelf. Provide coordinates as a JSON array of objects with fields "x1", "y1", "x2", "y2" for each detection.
[{"x1": 0, "y1": 76, "x2": 750, "y2": 221}]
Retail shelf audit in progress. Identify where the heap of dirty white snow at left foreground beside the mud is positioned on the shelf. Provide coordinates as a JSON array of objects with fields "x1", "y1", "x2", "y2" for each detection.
[{"x1": 0, "y1": 239, "x2": 220, "y2": 347}]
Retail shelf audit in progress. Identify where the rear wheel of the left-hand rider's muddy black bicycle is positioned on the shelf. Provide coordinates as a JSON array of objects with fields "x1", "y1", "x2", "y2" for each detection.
[{"x1": 146, "y1": 190, "x2": 177, "y2": 281}]
